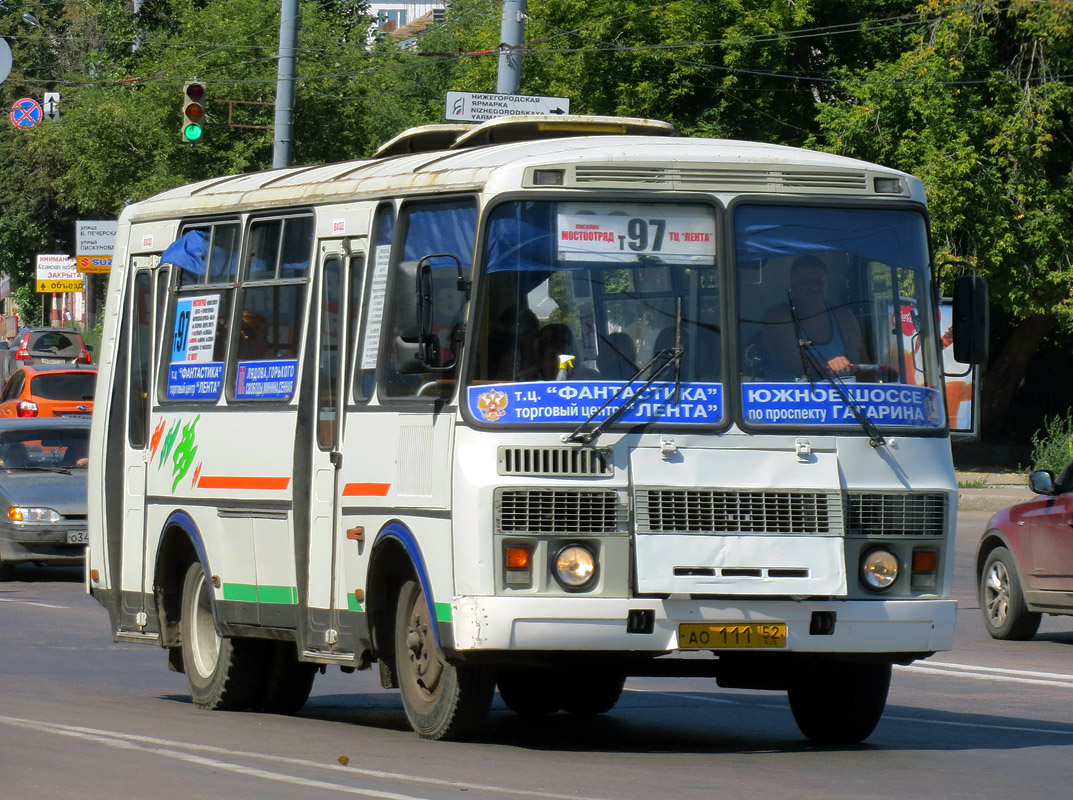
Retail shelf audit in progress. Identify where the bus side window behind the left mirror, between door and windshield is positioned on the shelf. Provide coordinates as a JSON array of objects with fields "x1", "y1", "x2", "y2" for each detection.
[{"x1": 381, "y1": 199, "x2": 476, "y2": 399}]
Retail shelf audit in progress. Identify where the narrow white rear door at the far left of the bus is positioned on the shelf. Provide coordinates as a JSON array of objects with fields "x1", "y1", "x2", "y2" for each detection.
[{"x1": 117, "y1": 255, "x2": 168, "y2": 634}]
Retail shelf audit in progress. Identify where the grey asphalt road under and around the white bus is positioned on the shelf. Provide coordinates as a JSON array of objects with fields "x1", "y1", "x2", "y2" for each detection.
[{"x1": 0, "y1": 490, "x2": 1073, "y2": 800}]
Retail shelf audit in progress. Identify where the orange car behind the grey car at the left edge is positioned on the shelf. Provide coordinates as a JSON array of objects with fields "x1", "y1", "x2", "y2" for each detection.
[{"x1": 0, "y1": 365, "x2": 97, "y2": 418}]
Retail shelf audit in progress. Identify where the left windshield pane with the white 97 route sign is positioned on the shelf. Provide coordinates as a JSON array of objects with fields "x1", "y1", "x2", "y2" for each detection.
[{"x1": 467, "y1": 199, "x2": 723, "y2": 425}]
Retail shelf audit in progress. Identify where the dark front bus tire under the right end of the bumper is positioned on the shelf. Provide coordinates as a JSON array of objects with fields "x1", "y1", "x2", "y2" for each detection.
[{"x1": 787, "y1": 661, "x2": 891, "y2": 744}]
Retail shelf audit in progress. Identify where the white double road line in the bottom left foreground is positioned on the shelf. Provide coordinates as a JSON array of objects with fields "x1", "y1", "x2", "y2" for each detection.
[{"x1": 0, "y1": 715, "x2": 602, "y2": 800}]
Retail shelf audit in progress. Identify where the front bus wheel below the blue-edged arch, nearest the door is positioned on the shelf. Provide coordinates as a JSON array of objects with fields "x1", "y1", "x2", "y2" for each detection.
[{"x1": 395, "y1": 580, "x2": 496, "y2": 740}]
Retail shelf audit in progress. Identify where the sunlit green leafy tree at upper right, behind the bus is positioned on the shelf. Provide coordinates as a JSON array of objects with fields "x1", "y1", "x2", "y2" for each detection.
[{"x1": 817, "y1": 0, "x2": 1073, "y2": 426}]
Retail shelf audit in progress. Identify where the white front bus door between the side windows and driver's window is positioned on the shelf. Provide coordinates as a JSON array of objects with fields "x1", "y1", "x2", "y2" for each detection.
[{"x1": 298, "y1": 240, "x2": 365, "y2": 654}]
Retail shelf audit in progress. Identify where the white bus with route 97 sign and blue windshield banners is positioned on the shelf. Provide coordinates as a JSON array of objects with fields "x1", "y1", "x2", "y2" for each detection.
[{"x1": 87, "y1": 117, "x2": 986, "y2": 741}]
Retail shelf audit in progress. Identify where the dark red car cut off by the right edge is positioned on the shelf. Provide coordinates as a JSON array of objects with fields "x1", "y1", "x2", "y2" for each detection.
[{"x1": 976, "y1": 461, "x2": 1073, "y2": 640}]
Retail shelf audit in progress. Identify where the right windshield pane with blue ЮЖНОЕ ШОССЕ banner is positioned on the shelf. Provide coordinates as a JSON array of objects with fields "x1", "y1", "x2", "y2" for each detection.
[{"x1": 733, "y1": 205, "x2": 944, "y2": 428}]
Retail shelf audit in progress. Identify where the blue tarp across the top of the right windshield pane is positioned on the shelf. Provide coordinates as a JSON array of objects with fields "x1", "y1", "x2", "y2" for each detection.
[{"x1": 734, "y1": 206, "x2": 928, "y2": 269}]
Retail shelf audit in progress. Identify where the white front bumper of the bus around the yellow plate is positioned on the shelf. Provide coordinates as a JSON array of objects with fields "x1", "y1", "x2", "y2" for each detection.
[{"x1": 452, "y1": 597, "x2": 957, "y2": 654}]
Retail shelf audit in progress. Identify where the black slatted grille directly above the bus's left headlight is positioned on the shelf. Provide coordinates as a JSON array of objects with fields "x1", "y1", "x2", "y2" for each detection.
[{"x1": 495, "y1": 489, "x2": 627, "y2": 535}]
